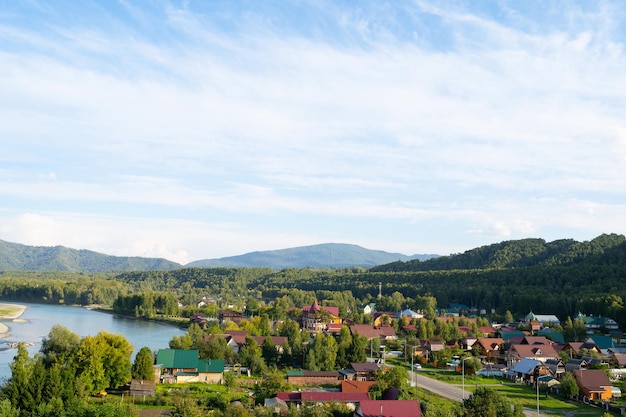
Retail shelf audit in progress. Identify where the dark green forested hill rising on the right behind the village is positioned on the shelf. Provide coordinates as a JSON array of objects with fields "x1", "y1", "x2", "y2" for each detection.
[{"x1": 371, "y1": 234, "x2": 626, "y2": 272}]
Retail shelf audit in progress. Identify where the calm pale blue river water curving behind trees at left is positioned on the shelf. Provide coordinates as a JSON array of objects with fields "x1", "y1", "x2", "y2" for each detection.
[{"x1": 0, "y1": 302, "x2": 185, "y2": 382}]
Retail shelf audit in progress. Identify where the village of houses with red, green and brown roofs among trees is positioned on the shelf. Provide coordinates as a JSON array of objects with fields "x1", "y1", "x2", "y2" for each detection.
[{"x1": 131, "y1": 301, "x2": 626, "y2": 417}]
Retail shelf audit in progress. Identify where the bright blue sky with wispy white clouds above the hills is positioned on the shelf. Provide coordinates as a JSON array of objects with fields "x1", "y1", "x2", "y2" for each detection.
[{"x1": 0, "y1": 0, "x2": 626, "y2": 264}]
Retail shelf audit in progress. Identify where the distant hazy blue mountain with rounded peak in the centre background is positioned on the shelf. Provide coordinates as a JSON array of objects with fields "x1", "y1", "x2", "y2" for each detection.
[{"x1": 186, "y1": 243, "x2": 438, "y2": 269}]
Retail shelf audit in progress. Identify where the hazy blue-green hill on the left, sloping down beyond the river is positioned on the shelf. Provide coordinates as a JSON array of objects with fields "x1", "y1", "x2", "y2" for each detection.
[{"x1": 0, "y1": 240, "x2": 182, "y2": 272}]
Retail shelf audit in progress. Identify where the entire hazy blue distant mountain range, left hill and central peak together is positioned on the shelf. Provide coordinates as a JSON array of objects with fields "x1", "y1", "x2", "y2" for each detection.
[{"x1": 0, "y1": 240, "x2": 438, "y2": 273}]
